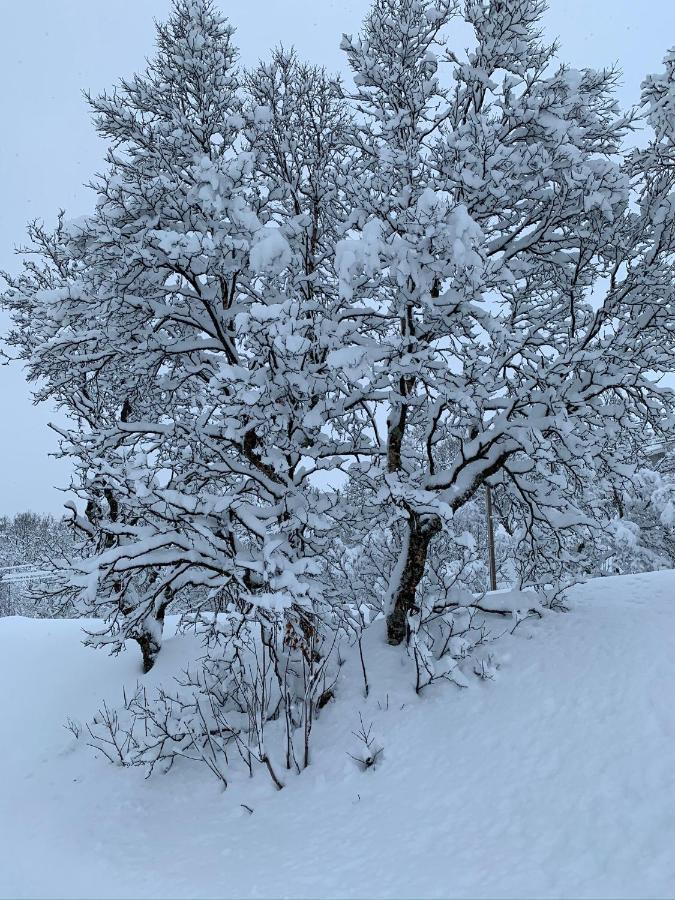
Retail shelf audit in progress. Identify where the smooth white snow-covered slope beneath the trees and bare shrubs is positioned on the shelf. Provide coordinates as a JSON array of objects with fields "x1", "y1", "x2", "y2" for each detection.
[{"x1": 0, "y1": 572, "x2": 675, "y2": 898}]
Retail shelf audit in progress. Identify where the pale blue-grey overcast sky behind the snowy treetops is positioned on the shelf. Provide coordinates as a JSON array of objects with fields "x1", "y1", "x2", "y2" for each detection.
[{"x1": 0, "y1": 0, "x2": 675, "y2": 515}]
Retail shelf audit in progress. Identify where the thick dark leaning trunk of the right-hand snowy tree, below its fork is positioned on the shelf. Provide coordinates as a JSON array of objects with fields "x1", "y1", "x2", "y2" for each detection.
[{"x1": 387, "y1": 512, "x2": 442, "y2": 645}]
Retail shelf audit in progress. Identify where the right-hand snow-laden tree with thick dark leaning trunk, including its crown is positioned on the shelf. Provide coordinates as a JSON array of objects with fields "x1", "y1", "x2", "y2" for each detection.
[{"x1": 338, "y1": 0, "x2": 673, "y2": 643}]
